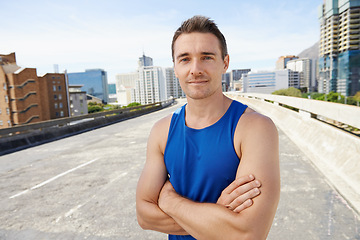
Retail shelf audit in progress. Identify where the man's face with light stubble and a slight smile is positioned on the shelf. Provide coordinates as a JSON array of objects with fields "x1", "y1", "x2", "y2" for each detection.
[{"x1": 174, "y1": 32, "x2": 229, "y2": 99}]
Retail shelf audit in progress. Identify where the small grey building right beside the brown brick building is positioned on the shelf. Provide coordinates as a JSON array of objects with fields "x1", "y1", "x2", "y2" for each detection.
[{"x1": 69, "y1": 85, "x2": 88, "y2": 117}]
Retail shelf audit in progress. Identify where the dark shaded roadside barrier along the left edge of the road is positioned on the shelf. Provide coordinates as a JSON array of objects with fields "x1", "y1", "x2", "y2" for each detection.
[{"x1": 0, "y1": 99, "x2": 174, "y2": 156}]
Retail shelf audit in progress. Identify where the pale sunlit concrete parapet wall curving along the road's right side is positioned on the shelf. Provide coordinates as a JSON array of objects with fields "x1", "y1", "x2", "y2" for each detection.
[{"x1": 228, "y1": 93, "x2": 360, "y2": 212}]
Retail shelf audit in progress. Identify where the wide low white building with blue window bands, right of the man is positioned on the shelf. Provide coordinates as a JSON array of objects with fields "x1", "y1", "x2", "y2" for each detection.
[{"x1": 242, "y1": 69, "x2": 300, "y2": 94}]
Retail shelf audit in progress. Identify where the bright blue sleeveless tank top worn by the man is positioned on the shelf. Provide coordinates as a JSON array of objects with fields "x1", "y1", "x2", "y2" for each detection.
[{"x1": 164, "y1": 101, "x2": 247, "y2": 239}]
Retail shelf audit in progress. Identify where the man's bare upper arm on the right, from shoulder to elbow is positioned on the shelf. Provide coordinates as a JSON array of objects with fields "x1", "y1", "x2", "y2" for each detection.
[{"x1": 237, "y1": 116, "x2": 280, "y2": 237}]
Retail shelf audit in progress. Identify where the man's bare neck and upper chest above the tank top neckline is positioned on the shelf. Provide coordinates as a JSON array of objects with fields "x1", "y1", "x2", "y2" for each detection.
[{"x1": 185, "y1": 92, "x2": 232, "y2": 129}]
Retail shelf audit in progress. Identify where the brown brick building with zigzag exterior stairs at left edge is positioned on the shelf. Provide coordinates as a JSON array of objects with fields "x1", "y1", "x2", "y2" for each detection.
[{"x1": 0, "y1": 53, "x2": 69, "y2": 128}]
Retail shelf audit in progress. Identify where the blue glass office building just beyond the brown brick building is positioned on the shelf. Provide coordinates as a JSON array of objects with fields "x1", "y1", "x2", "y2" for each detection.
[{"x1": 67, "y1": 69, "x2": 109, "y2": 103}]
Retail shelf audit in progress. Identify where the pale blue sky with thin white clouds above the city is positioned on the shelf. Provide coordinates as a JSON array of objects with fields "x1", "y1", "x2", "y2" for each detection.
[{"x1": 0, "y1": 0, "x2": 323, "y2": 83}]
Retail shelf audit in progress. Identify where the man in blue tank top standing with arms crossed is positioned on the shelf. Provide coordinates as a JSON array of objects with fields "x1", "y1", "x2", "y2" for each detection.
[{"x1": 136, "y1": 16, "x2": 280, "y2": 239}]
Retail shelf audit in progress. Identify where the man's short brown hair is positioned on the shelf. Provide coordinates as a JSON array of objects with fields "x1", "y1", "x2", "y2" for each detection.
[{"x1": 171, "y1": 15, "x2": 228, "y2": 61}]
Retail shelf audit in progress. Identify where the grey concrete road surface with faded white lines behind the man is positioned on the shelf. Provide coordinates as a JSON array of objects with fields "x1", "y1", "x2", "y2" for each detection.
[{"x1": 0, "y1": 100, "x2": 360, "y2": 240}]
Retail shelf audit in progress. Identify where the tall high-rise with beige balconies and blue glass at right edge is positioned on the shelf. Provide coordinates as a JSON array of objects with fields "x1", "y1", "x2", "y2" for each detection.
[{"x1": 318, "y1": 0, "x2": 360, "y2": 96}]
